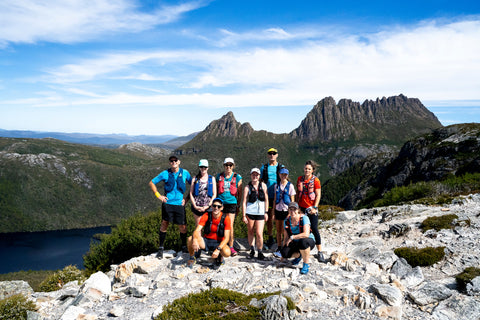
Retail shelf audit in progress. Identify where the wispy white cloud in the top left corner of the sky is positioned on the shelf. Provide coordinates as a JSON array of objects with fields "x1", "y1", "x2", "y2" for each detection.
[{"x1": 0, "y1": 0, "x2": 207, "y2": 45}]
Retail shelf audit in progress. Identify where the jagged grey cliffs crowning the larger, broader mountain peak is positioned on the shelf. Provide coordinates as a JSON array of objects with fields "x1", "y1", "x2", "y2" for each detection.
[{"x1": 290, "y1": 95, "x2": 442, "y2": 143}]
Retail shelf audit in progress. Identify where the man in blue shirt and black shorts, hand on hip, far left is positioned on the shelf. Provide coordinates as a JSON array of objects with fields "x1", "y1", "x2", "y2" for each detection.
[{"x1": 149, "y1": 156, "x2": 192, "y2": 259}]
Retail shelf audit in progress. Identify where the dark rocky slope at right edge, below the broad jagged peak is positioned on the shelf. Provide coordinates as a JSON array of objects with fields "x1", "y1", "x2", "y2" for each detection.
[{"x1": 340, "y1": 124, "x2": 480, "y2": 208}]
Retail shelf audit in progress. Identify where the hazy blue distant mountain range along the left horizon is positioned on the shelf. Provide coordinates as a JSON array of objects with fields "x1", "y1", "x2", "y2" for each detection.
[{"x1": 0, "y1": 129, "x2": 195, "y2": 149}]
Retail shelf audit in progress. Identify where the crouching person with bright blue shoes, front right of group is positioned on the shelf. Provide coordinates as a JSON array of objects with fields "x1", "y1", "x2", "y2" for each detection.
[{"x1": 281, "y1": 202, "x2": 315, "y2": 274}]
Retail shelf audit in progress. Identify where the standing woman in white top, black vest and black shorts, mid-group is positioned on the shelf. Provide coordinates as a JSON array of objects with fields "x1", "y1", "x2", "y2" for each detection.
[{"x1": 242, "y1": 168, "x2": 268, "y2": 260}]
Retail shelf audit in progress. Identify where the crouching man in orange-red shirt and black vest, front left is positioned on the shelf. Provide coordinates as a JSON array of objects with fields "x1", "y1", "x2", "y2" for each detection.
[{"x1": 187, "y1": 198, "x2": 231, "y2": 268}]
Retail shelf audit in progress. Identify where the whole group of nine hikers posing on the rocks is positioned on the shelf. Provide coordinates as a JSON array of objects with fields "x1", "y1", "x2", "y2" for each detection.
[{"x1": 149, "y1": 148, "x2": 321, "y2": 274}]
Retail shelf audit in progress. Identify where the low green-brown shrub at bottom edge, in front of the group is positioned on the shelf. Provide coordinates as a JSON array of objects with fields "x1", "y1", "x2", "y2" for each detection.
[{"x1": 155, "y1": 288, "x2": 295, "y2": 320}]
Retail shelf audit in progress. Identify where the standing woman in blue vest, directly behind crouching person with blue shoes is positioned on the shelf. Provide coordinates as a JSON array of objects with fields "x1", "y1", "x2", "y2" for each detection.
[{"x1": 269, "y1": 168, "x2": 296, "y2": 258}]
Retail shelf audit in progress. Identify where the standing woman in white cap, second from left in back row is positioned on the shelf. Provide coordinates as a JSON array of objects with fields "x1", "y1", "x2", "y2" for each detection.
[{"x1": 190, "y1": 159, "x2": 217, "y2": 227}]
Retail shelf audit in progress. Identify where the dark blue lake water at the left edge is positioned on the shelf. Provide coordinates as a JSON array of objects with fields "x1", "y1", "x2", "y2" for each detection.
[{"x1": 0, "y1": 227, "x2": 111, "y2": 273}]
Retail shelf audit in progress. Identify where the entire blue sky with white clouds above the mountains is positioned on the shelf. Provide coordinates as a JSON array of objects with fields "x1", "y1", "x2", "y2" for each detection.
[{"x1": 0, "y1": 0, "x2": 480, "y2": 135}]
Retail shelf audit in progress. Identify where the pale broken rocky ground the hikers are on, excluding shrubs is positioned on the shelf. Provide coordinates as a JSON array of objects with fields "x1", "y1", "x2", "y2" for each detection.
[{"x1": 4, "y1": 194, "x2": 480, "y2": 320}]
